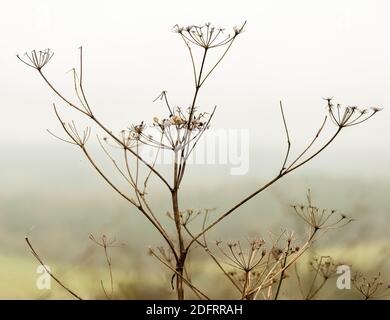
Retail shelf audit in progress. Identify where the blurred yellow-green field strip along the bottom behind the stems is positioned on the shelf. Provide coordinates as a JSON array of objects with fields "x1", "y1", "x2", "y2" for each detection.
[{"x1": 0, "y1": 242, "x2": 390, "y2": 299}]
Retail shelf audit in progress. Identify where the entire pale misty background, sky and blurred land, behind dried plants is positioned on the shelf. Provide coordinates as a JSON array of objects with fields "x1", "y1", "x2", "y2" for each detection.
[{"x1": 0, "y1": 0, "x2": 390, "y2": 298}]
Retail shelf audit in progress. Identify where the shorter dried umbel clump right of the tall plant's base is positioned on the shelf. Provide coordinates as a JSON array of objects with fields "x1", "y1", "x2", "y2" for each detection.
[{"x1": 186, "y1": 191, "x2": 352, "y2": 300}]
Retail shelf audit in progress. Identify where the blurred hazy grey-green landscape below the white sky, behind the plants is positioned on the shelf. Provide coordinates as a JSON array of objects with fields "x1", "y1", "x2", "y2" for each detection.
[{"x1": 0, "y1": 149, "x2": 390, "y2": 299}]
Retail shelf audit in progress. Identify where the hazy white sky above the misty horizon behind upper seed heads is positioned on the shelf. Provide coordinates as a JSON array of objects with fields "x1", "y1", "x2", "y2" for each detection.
[{"x1": 0, "y1": 0, "x2": 390, "y2": 162}]
